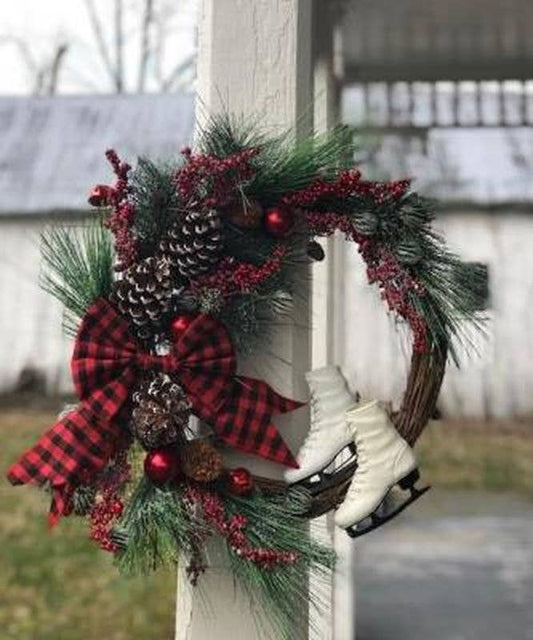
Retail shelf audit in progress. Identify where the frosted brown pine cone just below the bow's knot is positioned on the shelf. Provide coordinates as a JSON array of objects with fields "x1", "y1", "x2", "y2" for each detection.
[{"x1": 131, "y1": 373, "x2": 191, "y2": 450}]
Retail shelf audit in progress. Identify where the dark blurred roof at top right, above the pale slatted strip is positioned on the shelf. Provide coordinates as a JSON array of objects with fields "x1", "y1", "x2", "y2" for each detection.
[{"x1": 342, "y1": 0, "x2": 533, "y2": 82}]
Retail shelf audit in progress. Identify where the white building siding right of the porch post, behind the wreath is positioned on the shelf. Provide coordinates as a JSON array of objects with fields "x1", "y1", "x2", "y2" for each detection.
[{"x1": 345, "y1": 211, "x2": 533, "y2": 418}]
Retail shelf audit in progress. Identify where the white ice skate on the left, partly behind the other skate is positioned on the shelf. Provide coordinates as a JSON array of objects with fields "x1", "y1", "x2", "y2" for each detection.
[{"x1": 285, "y1": 366, "x2": 355, "y2": 494}]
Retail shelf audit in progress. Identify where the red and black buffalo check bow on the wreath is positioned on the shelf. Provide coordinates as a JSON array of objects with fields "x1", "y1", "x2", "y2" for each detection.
[{"x1": 8, "y1": 299, "x2": 302, "y2": 524}]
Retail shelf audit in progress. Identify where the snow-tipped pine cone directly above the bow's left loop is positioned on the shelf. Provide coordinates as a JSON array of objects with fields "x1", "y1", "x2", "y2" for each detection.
[{"x1": 110, "y1": 257, "x2": 175, "y2": 337}]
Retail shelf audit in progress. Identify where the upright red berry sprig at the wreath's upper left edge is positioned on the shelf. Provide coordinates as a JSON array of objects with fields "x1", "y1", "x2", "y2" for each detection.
[{"x1": 105, "y1": 149, "x2": 138, "y2": 271}]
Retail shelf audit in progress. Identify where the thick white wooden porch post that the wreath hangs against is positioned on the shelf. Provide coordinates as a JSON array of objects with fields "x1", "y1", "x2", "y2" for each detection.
[{"x1": 175, "y1": 0, "x2": 313, "y2": 640}]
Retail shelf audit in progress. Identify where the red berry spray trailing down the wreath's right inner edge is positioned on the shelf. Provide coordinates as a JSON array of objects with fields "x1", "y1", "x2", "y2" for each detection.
[{"x1": 306, "y1": 211, "x2": 428, "y2": 353}]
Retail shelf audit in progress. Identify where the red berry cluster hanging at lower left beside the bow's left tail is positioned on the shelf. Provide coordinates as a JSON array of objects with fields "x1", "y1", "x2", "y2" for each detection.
[{"x1": 89, "y1": 451, "x2": 130, "y2": 553}]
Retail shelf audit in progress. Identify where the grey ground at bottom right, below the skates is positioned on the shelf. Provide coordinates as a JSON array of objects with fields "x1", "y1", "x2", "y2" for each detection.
[{"x1": 356, "y1": 489, "x2": 533, "y2": 640}]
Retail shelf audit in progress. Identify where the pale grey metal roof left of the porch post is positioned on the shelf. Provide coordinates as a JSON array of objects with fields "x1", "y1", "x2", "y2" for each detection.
[{"x1": 0, "y1": 94, "x2": 194, "y2": 215}]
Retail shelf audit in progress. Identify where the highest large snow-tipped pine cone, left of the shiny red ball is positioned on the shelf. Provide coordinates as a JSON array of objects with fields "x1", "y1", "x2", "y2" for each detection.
[{"x1": 159, "y1": 209, "x2": 224, "y2": 279}]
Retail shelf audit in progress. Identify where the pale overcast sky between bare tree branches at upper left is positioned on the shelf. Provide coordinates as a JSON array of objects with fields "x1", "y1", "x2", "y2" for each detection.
[{"x1": 0, "y1": 0, "x2": 196, "y2": 94}]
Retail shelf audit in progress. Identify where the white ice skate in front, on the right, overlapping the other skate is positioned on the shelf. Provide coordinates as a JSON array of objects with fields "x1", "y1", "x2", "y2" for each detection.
[{"x1": 335, "y1": 401, "x2": 429, "y2": 538}]
